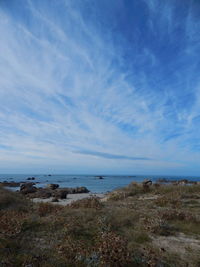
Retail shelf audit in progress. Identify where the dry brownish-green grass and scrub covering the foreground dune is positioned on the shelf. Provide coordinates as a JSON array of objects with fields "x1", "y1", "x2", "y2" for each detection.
[{"x1": 0, "y1": 183, "x2": 200, "y2": 267}]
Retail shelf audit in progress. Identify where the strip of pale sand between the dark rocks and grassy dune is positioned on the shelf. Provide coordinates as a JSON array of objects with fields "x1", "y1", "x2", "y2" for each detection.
[{"x1": 32, "y1": 193, "x2": 105, "y2": 206}]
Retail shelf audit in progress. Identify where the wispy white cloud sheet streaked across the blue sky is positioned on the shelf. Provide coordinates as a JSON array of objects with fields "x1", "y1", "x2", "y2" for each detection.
[{"x1": 0, "y1": 1, "x2": 199, "y2": 172}]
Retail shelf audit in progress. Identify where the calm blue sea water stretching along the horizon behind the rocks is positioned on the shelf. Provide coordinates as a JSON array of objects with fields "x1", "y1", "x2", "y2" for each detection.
[{"x1": 0, "y1": 174, "x2": 200, "y2": 193}]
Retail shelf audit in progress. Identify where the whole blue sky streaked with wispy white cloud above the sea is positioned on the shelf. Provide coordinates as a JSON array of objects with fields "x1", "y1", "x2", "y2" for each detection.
[{"x1": 0, "y1": 0, "x2": 200, "y2": 176}]
